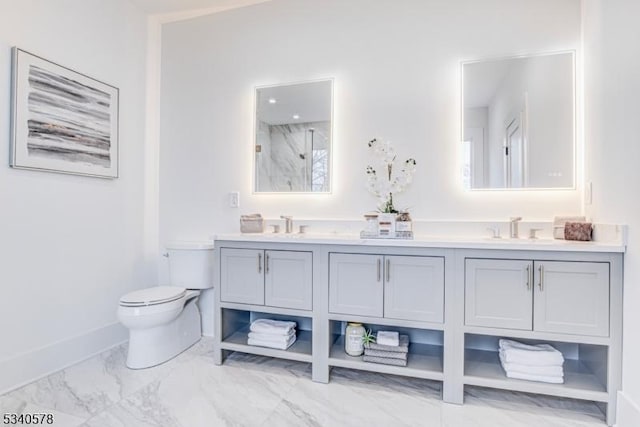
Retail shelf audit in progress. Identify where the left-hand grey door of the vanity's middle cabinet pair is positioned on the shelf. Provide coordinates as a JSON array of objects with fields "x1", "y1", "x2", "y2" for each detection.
[{"x1": 329, "y1": 253, "x2": 384, "y2": 317}]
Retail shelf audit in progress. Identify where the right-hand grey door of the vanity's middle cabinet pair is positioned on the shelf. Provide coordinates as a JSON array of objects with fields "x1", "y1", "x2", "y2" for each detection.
[{"x1": 384, "y1": 256, "x2": 444, "y2": 323}]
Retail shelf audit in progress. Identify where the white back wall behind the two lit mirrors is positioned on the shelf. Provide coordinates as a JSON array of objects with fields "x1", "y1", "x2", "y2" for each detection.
[{"x1": 160, "y1": 0, "x2": 581, "y2": 244}]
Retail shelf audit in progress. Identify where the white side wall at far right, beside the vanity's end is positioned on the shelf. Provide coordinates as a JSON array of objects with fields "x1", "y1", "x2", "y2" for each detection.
[{"x1": 583, "y1": 0, "x2": 640, "y2": 427}]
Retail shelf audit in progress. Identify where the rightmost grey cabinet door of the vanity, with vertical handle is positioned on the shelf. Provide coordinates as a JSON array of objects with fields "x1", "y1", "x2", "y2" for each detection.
[{"x1": 533, "y1": 261, "x2": 609, "y2": 337}]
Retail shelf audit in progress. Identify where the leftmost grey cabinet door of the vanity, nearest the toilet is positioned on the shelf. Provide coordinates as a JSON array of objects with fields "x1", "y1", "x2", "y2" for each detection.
[{"x1": 220, "y1": 248, "x2": 264, "y2": 305}]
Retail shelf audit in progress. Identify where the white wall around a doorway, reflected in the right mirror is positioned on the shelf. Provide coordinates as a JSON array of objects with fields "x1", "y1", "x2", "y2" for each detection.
[{"x1": 488, "y1": 53, "x2": 575, "y2": 188}]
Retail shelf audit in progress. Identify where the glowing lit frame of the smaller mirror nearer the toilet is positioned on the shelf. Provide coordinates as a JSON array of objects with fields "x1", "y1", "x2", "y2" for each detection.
[{"x1": 251, "y1": 77, "x2": 335, "y2": 195}]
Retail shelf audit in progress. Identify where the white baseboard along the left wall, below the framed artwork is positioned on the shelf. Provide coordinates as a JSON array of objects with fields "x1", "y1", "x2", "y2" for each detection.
[{"x1": 0, "y1": 323, "x2": 129, "y2": 395}]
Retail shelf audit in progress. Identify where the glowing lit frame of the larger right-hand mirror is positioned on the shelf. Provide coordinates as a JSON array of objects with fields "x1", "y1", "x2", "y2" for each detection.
[{"x1": 458, "y1": 49, "x2": 579, "y2": 192}]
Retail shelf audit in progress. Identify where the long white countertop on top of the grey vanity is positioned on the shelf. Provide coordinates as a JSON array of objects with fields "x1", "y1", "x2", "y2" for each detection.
[{"x1": 215, "y1": 233, "x2": 626, "y2": 253}]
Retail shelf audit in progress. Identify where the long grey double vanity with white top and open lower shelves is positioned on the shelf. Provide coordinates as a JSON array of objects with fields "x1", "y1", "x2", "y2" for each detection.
[{"x1": 214, "y1": 235, "x2": 624, "y2": 425}]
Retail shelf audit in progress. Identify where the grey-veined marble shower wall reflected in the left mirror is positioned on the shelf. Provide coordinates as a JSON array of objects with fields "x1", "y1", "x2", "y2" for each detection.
[{"x1": 256, "y1": 121, "x2": 331, "y2": 192}]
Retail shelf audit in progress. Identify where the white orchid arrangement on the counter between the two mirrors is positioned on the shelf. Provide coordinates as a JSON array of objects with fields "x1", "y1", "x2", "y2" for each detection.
[{"x1": 367, "y1": 138, "x2": 416, "y2": 213}]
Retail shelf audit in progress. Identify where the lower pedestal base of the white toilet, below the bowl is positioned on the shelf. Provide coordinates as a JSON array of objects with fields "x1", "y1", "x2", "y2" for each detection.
[{"x1": 127, "y1": 298, "x2": 202, "y2": 369}]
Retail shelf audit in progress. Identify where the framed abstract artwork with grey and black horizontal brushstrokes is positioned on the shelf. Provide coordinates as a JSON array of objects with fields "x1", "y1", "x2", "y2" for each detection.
[{"x1": 10, "y1": 47, "x2": 119, "y2": 178}]
